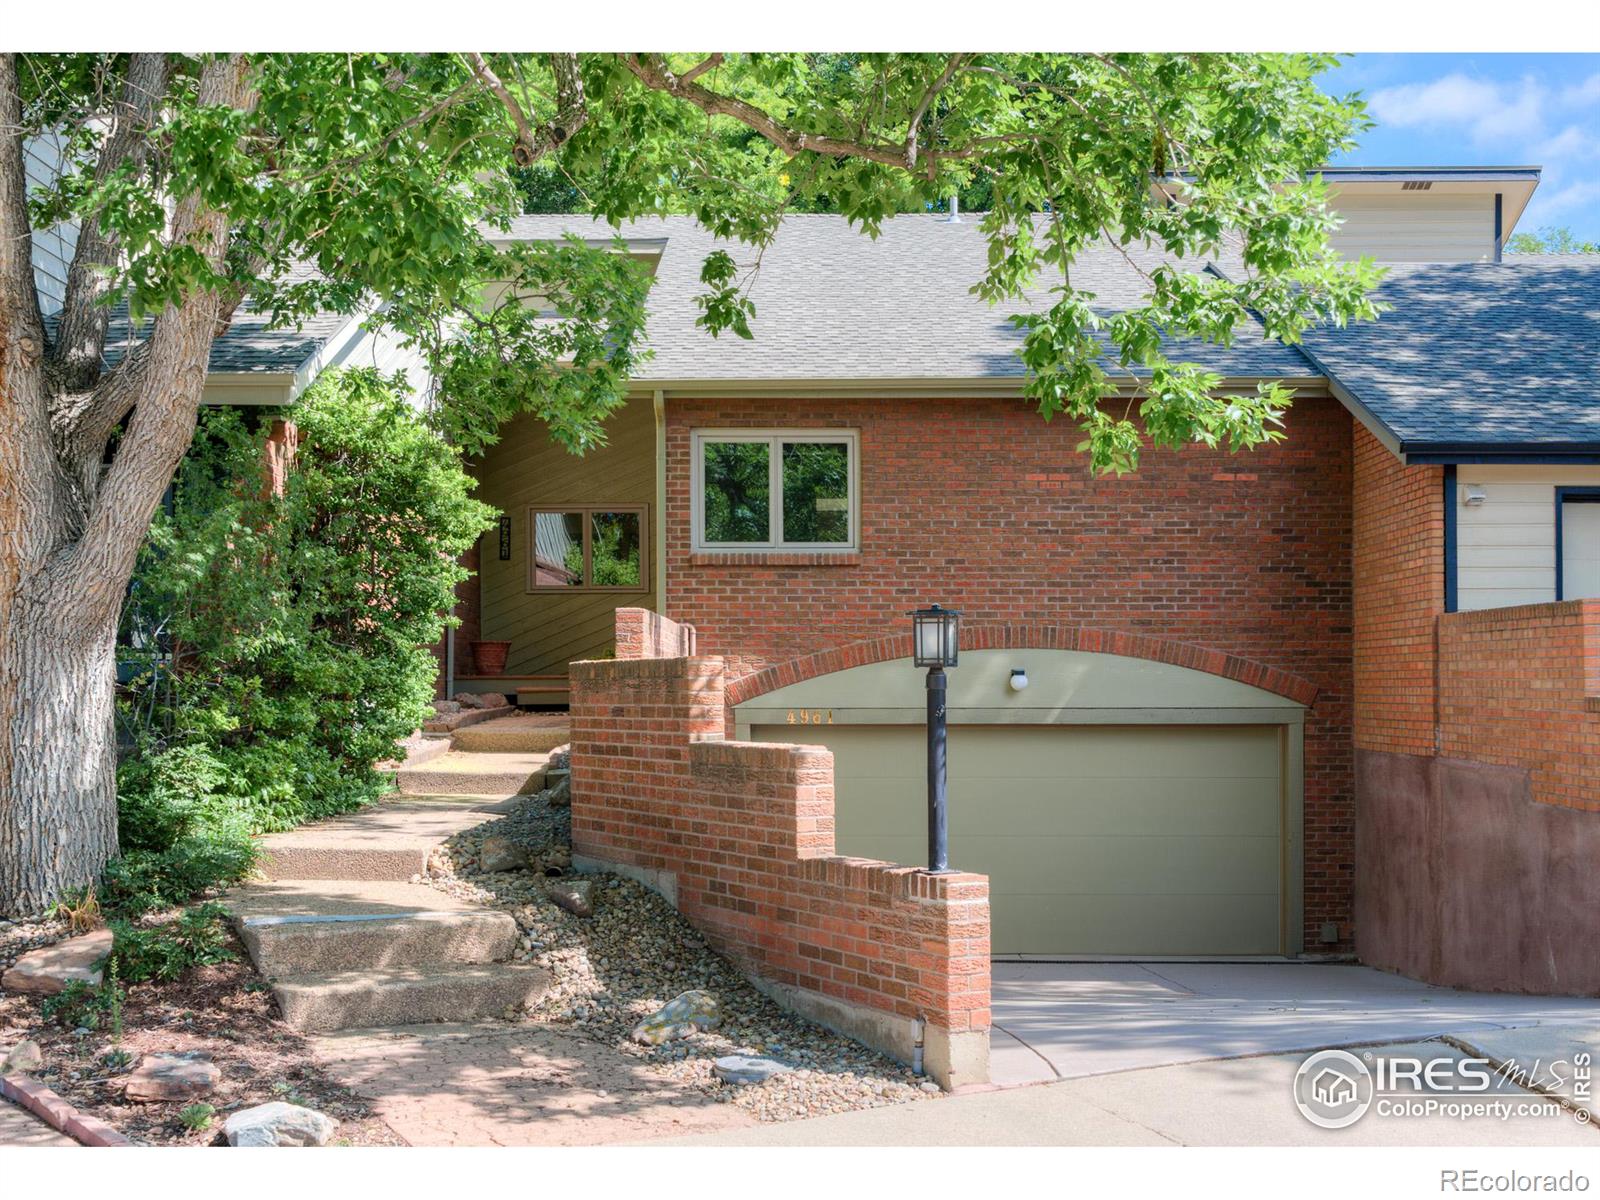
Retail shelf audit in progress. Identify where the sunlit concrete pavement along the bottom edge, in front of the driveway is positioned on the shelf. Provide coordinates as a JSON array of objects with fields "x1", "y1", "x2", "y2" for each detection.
[{"x1": 670, "y1": 1042, "x2": 1600, "y2": 1150}]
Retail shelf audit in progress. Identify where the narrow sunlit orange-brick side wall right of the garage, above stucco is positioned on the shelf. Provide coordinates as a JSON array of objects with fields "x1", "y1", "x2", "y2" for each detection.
[{"x1": 1355, "y1": 426, "x2": 1445, "y2": 754}]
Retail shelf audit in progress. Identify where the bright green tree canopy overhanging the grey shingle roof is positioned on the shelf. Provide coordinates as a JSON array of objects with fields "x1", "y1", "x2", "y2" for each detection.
[{"x1": 12, "y1": 53, "x2": 1378, "y2": 469}]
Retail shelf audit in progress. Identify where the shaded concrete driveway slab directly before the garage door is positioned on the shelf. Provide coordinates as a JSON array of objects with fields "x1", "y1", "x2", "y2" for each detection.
[{"x1": 989, "y1": 962, "x2": 1600, "y2": 1086}]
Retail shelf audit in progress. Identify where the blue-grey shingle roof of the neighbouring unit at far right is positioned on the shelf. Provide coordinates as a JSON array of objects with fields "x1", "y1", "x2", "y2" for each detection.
[{"x1": 1306, "y1": 254, "x2": 1600, "y2": 453}]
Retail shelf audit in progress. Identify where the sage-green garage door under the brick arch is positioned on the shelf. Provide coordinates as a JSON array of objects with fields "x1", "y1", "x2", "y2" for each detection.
[{"x1": 752, "y1": 725, "x2": 1286, "y2": 955}]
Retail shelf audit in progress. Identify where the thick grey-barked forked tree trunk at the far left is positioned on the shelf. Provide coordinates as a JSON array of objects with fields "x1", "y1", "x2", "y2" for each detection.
[{"x1": 0, "y1": 54, "x2": 248, "y2": 917}]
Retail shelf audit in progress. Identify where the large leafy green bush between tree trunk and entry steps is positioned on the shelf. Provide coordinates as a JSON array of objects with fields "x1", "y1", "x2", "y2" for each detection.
[{"x1": 112, "y1": 370, "x2": 494, "y2": 915}]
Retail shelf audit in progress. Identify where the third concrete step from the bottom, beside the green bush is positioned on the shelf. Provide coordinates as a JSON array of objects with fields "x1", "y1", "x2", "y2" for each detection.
[{"x1": 258, "y1": 800, "x2": 507, "y2": 883}]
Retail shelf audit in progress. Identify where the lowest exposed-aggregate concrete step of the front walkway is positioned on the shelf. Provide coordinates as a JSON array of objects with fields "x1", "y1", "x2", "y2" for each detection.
[{"x1": 272, "y1": 963, "x2": 550, "y2": 1032}]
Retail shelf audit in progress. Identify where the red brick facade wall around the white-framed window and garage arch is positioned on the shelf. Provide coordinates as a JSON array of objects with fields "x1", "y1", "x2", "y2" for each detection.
[{"x1": 664, "y1": 395, "x2": 1354, "y2": 949}]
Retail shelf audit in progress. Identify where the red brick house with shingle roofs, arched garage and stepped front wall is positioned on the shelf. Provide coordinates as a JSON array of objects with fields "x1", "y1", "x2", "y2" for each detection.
[{"x1": 156, "y1": 168, "x2": 1600, "y2": 1077}]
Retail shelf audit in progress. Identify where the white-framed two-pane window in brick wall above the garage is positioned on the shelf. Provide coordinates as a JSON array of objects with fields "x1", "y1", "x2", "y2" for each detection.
[{"x1": 694, "y1": 430, "x2": 859, "y2": 550}]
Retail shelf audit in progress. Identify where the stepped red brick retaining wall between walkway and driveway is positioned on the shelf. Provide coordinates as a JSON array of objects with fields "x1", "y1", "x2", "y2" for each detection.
[{"x1": 571, "y1": 658, "x2": 989, "y2": 1083}]
